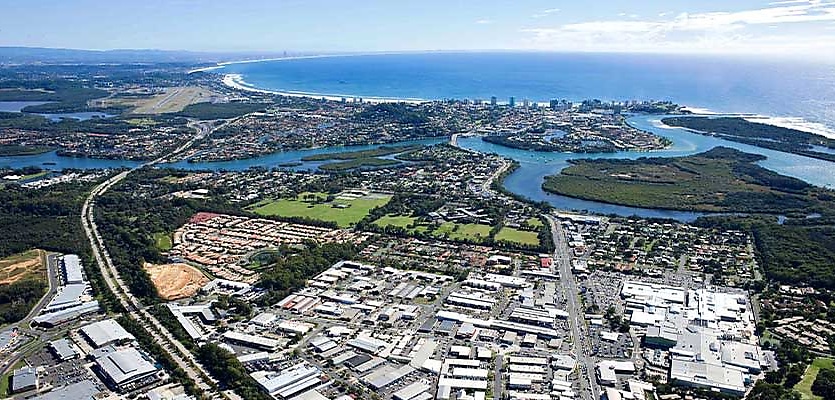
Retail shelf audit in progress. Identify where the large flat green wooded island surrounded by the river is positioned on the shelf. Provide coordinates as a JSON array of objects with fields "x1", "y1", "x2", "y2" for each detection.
[{"x1": 542, "y1": 147, "x2": 832, "y2": 214}]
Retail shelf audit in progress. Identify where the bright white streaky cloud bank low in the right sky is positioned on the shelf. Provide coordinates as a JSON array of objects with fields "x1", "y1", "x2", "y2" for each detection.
[{"x1": 522, "y1": 0, "x2": 835, "y2": 57}]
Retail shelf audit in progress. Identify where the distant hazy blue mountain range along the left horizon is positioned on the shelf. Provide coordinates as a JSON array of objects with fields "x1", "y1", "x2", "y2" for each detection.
[{"x1": 0, "y1": 46, "x2": 303, "y2": 65}]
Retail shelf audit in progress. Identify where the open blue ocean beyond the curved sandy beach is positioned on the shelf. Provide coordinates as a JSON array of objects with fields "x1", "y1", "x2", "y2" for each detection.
[{"x1": 218, "y1": 52, "x2": 835, "y2": 133}]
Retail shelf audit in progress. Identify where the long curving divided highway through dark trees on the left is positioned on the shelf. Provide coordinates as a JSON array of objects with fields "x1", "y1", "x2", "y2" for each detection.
[{"x1": 81, "y1": 122, "x2": 224, "y2": 399}]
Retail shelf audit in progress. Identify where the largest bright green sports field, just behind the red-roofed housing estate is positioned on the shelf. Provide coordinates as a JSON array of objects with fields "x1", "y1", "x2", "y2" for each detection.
[{"x1": 252, "y1": 193, "x2": 391, "y2": 228}]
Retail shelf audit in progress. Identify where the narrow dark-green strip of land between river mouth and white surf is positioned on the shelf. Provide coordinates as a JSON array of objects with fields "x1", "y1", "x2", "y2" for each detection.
[{"x1": 661, "y1": 117, "x2": 835, "y2": 162}]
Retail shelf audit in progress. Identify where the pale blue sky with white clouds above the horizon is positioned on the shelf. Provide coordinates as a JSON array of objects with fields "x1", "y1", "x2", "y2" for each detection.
[{"x1": 0, "y1": 0, "x2": 835, "y2": 56}]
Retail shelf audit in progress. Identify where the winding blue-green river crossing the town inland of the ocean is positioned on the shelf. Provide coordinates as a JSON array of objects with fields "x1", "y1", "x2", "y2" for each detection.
[{"x1": 0, "y1": 115, "x2": 835, "y2": 221}]
